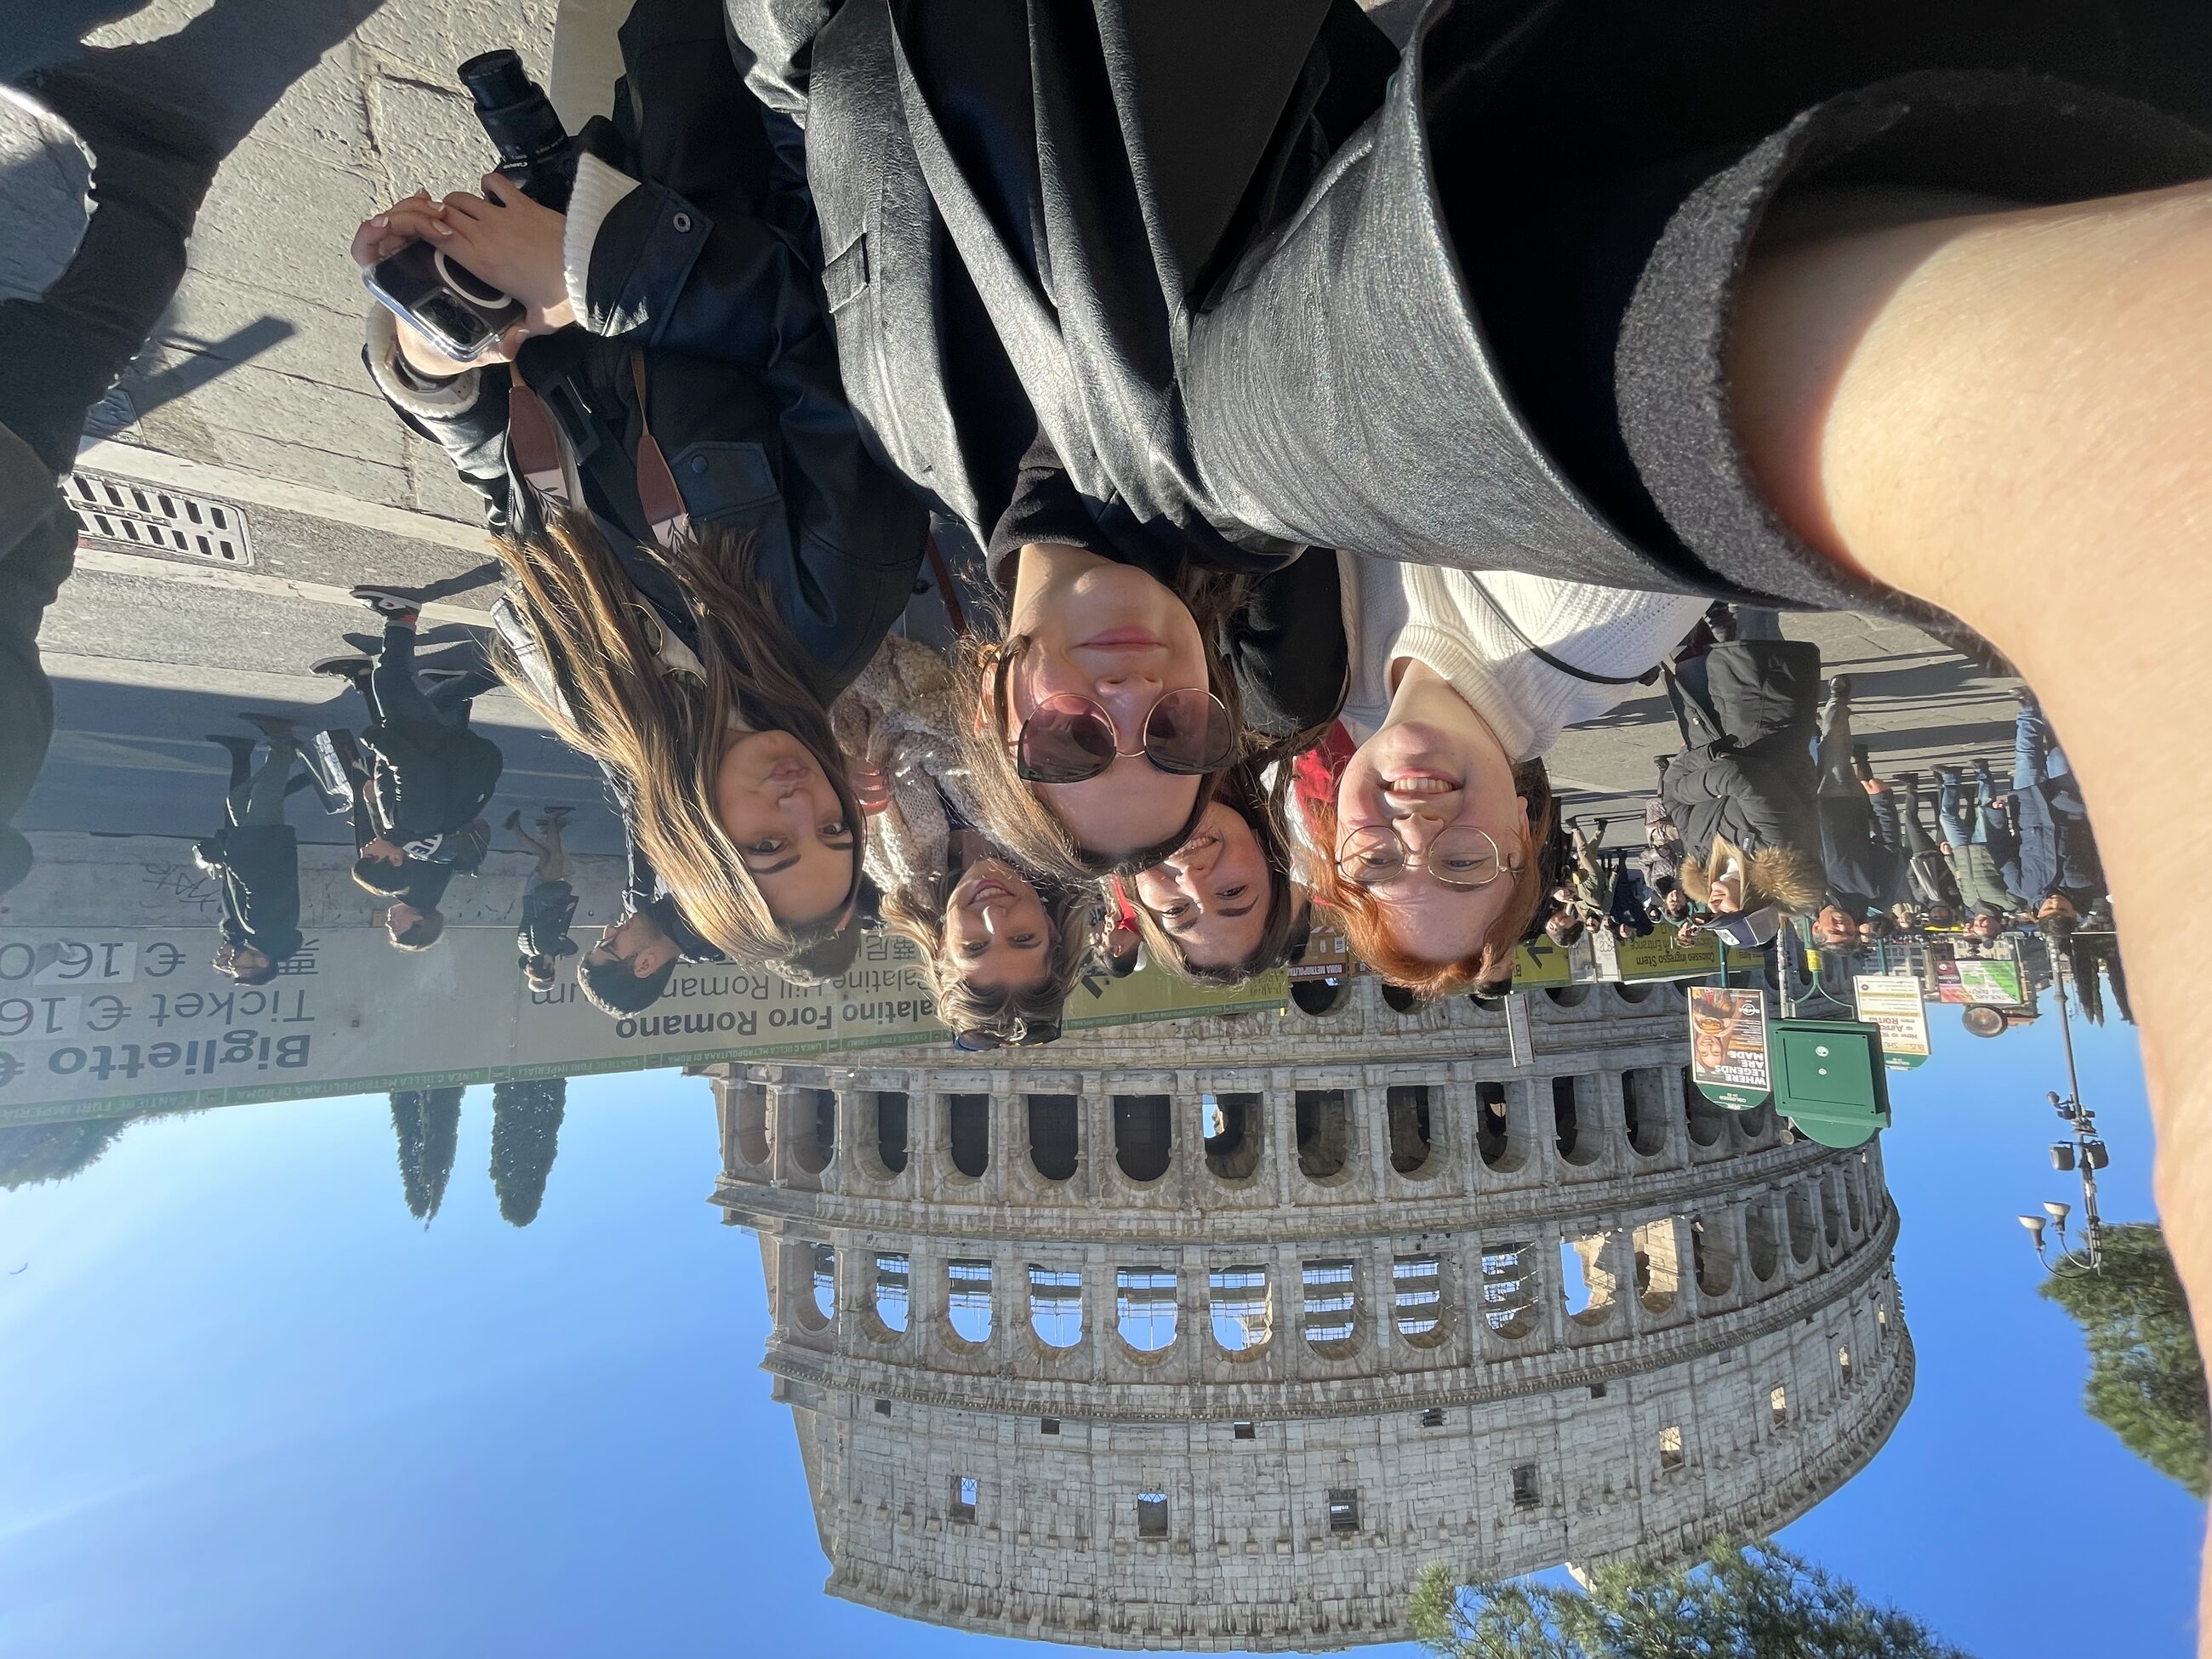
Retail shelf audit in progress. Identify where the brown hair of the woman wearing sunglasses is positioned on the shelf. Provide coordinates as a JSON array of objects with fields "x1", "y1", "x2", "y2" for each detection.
[{"x1": 951, "y1": 567, "x2": 1250, "y2": 887}]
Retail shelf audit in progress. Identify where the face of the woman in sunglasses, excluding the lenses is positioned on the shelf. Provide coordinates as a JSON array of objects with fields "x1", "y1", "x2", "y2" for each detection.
[{"x1": 1002, "y1": 546, "x2": 1208, "y2": 856}]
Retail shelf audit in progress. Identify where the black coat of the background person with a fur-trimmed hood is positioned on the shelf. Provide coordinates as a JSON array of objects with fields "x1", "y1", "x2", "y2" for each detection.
[{"x1": 1659, "y1": 639, "x2": 1821, "y2": 860}]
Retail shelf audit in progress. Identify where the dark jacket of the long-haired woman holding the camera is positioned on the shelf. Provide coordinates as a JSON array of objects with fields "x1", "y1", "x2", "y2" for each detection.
[{"x1": 369, "y1": 0, "x2": 929, "y2": 699}]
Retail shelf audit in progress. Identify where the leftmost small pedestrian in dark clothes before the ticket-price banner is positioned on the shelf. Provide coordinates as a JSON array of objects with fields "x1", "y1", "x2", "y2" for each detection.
[{"x1": 192, "y1": 715, "x2": 301, "y2": 984}]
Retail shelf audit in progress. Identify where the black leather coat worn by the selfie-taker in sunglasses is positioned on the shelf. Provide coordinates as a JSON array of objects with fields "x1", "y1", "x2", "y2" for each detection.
[{"x1": 727, "y1": 0, "x2": 2212, "y2": 606}]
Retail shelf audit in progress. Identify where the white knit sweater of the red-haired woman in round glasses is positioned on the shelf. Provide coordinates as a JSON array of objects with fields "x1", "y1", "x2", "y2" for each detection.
[{"x1": 1338, "y1": 553, "x2": 1706, "y2": 761}]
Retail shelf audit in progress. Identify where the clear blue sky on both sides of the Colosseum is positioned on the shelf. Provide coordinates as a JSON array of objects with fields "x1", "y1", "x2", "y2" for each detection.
[{"x1": 0, "y1": 1013, "x2": 2203, "y2": 1659}]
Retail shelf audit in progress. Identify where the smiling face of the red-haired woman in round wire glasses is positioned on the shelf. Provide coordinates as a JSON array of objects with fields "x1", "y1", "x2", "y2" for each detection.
[{"x1": 1334, "y1": 661, "x2": 1529, "y2": 962}]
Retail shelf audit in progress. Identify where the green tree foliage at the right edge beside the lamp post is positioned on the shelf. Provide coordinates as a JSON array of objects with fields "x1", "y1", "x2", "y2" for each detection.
[{"x1": 2044, "y1": 1221, "x2": 2212, "y2": 1497}]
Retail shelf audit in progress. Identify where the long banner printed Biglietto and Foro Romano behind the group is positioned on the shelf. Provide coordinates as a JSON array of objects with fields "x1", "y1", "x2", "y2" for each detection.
[{"x1": 0, "y1": 926, "x2": 1286, "y2": 1124}]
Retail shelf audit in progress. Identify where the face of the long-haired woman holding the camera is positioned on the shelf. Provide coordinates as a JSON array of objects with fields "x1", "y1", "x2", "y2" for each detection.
[{"x1": 715, "y1": 733, "x2": 860, "y2": 926}]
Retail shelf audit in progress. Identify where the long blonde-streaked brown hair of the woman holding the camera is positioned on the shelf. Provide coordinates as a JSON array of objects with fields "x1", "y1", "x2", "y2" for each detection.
[{"x1": 493, "y1": 509, "x2": 865, "y2": 962}]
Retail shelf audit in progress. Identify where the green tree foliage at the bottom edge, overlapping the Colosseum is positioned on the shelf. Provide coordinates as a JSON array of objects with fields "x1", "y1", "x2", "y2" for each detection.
[{"x1": 1407, "y1": 1540, "x2": 1966, "y2": 1659}]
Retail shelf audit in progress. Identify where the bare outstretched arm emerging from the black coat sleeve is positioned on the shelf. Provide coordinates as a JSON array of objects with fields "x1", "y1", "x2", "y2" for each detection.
[{"x1": 1728, "y1": 184, "x2": 2212, "y2": 1628}]
